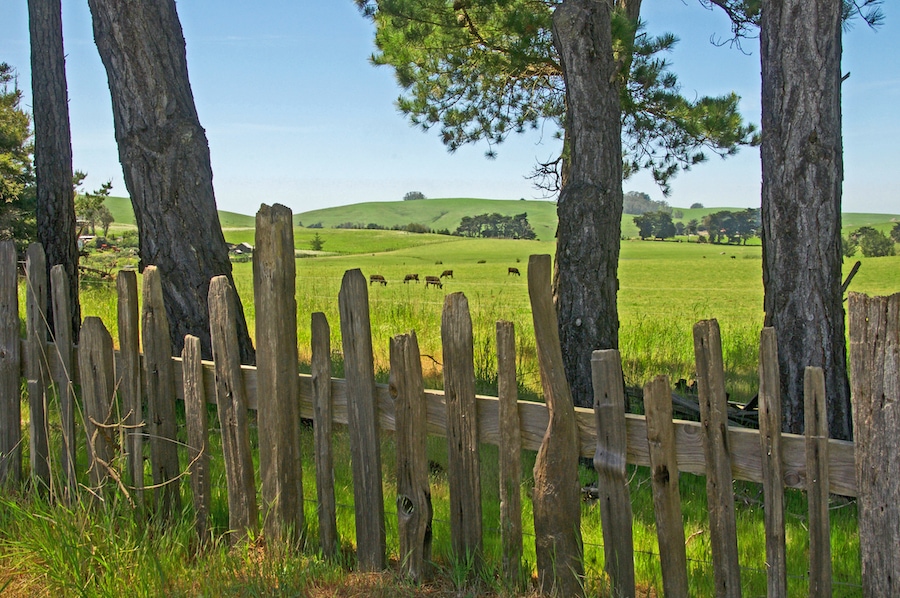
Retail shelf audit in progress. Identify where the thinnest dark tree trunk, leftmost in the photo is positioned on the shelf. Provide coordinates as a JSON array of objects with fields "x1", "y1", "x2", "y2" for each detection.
[{"x1": 28, "y1": 0, "x2": 81, "y2": 340}]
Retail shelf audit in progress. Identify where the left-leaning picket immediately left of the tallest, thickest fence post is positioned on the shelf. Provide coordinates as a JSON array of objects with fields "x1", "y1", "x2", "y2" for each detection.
[{"x1": 209, "y1": 276, "x2": 259, "y2": 543}]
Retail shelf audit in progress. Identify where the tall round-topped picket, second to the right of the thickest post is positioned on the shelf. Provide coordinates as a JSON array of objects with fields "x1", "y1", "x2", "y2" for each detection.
[{"x1": 338, "y1": 269, "x2": 387, "y2": 571}]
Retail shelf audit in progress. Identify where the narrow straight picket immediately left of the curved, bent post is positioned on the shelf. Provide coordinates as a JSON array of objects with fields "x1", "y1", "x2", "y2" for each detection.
[{"x1": 497, "y1": 321, "x2": 525, "y2": 588}]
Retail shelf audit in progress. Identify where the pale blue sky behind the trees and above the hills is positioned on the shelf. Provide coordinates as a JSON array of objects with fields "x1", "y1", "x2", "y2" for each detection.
[{"x1": 0, "y1": 0, "x2": 900, "y2": 214}]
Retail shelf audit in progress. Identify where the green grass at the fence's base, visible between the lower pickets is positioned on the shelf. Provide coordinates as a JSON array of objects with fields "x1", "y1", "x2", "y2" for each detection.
[{"x1": 0, "y1": 413, "x2": 860, "y2": 597}]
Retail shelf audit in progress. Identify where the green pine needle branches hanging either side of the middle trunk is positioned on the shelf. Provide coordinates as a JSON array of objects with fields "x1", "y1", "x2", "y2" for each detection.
[{"x1": 356, "y1": 0, "x2": 758, "y2": 193}]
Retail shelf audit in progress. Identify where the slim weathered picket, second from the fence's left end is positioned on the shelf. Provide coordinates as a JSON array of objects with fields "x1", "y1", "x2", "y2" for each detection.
[{"x1": 25, "y1": 243, "x2": 50, "y2": 492}]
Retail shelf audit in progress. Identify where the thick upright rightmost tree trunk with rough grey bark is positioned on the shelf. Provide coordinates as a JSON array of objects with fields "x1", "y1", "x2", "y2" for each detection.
[{"x1": 760, "y1": 0, "x2": 851, "y2": 439}]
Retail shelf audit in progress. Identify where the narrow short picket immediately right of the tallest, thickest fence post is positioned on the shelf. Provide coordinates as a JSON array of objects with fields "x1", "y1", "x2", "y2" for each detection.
[{"x1": 312, "y1": 312, "x2": 339, "y2": 557}]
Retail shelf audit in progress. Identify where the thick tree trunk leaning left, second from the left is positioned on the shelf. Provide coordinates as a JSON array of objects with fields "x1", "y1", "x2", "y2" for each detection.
[{"x1": 88, "y1": 0, "x2": 253, "y2": 363}]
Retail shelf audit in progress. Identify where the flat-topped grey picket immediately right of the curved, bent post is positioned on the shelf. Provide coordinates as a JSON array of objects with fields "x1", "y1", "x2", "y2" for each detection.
[{"x1": 596, "y1": 349, "x2": 635, "y2": 598}]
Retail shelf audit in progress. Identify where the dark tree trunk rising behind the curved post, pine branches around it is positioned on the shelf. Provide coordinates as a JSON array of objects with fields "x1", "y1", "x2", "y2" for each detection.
[{"x1": 553, "y1": 0, "x2": 622, "y2": 407}]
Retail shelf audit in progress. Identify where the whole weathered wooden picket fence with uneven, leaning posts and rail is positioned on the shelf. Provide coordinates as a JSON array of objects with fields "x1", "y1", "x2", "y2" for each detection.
[{"x1": 0, "y1": 205, "x2": 900, "y2": 596}]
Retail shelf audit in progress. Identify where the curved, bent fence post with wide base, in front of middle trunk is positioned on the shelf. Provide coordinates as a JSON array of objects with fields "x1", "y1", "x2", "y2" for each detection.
[{"x1": 528, "y1": 255, "x2": 584, "y2": 596}]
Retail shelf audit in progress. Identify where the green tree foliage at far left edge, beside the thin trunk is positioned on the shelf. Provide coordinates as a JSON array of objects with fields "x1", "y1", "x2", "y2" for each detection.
[{"x1": 0, "y1": 62, "x2": 37, "y2": 251}]
